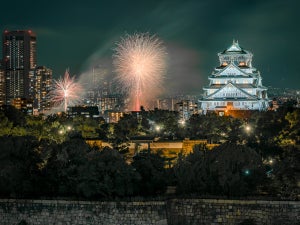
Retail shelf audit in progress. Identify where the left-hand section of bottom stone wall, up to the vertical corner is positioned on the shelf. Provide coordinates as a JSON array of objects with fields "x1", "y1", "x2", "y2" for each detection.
[{"x1": 0, "y1": 200, "x2": 167, "y2": 225}]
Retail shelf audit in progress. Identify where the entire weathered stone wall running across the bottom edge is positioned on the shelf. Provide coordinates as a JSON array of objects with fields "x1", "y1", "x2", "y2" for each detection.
[{"x1": 0, "y1": 199, "x2": 300, "y2": 225}]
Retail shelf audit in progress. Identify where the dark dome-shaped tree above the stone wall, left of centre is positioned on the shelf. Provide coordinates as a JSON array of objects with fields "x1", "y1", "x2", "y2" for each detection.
[{"x1": 77, "y1": 148, "x2": 140, "y2": 198}]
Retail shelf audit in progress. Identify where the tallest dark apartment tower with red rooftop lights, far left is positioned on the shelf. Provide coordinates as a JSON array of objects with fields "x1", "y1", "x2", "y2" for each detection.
[{"x1": 2, "y1": 30, "x2": 36, "y2": 105}]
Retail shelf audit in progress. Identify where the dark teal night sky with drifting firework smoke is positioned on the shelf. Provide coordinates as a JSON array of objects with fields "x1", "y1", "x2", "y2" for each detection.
[{"x1": 0, "y1": 0, "x2": 300, "y2": 94}]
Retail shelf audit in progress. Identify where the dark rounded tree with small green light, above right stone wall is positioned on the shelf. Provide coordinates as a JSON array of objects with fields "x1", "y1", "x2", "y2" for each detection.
[{"x1": 211, "y1": 143, "x2": 266, "y2": 196}]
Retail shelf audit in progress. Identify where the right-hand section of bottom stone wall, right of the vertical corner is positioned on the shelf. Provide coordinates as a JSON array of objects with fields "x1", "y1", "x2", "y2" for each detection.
[{"x1": 167, "y1": 199, "x2": 300, "y2": 225}]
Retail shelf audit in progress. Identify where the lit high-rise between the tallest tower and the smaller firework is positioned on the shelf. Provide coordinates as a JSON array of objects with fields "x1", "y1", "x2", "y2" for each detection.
[{"x1": 32, "y1": 66, "x2": 52, "y2": 113}]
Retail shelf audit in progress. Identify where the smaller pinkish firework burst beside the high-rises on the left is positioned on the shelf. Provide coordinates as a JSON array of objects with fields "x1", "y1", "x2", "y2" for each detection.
[{"x1": 50, "y1": 70, "x2": 83, "y2": 112}]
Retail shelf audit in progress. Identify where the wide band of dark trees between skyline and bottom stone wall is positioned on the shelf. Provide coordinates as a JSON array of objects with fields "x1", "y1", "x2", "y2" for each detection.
[{"x1": 0, "y1": 107, "x2": 300, "y2": 199}]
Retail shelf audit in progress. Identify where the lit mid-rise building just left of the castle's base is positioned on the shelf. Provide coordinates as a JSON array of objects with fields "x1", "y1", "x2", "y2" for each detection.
[{"x1": 175, "y1": 100, "x2": 198, "y2": 121}]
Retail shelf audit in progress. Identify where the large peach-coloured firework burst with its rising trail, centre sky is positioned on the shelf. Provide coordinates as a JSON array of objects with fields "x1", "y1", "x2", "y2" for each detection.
[{"x1": 113, "y1": 33, "x2": 166, "y2": 111}]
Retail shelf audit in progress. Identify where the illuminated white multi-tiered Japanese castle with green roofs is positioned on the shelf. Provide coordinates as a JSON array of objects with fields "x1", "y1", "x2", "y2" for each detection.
[{"x1": 199, "y1": 41, "x2": 269, "y2": 114}]
